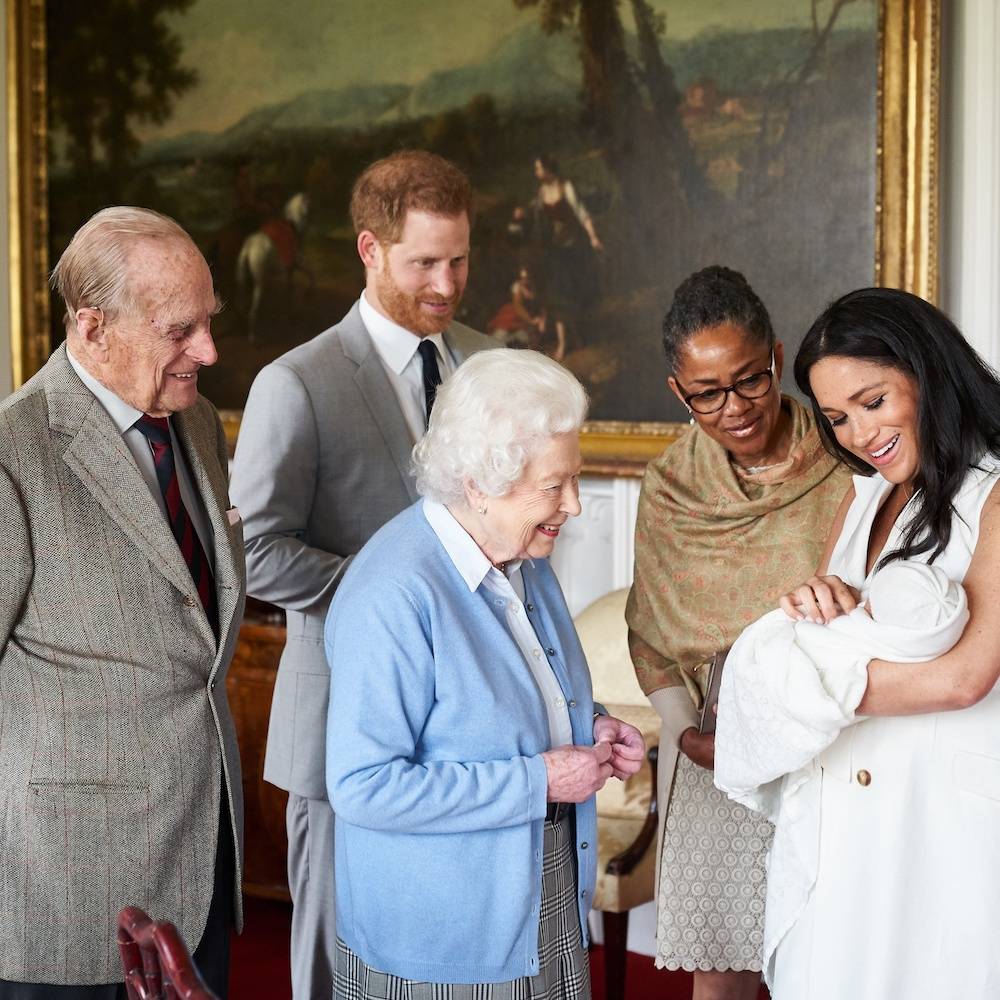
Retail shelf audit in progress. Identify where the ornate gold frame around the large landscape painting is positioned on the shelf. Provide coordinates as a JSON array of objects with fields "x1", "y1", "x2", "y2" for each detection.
[{"x1": 6, "y1": 0, "x2": 940, "y2": 474}]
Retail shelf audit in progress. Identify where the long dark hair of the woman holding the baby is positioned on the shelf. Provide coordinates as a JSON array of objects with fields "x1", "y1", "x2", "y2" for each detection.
[{"x1": 795, "y1": 288, "x2": 1000, "y2": 569}]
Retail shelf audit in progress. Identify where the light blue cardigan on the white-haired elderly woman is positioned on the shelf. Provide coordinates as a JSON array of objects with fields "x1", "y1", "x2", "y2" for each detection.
[{"x1": 326, "y1": 502, "x2": 597, "y2": 983}]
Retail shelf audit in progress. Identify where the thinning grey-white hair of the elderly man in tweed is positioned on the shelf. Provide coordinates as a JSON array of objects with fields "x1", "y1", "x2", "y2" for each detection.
[{"x1": 49, "y1": 205, "x2": 195, "y2": 330}]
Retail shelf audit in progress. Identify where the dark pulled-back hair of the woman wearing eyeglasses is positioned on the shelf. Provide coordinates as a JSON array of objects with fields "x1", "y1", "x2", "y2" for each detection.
[{"x1": 663, "y1": 264, "x2": 774, "y2": 373}]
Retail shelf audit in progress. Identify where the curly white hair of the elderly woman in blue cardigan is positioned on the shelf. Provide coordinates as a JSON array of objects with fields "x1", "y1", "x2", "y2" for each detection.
[{"x1": 413, "y1": 350, "x2": 587, "y2": 504}]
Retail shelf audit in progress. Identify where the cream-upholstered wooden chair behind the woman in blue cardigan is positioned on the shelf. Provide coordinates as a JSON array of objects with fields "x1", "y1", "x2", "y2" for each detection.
[{"x1": 575, "y1": 590, "x2": 660, "y2": 1000}]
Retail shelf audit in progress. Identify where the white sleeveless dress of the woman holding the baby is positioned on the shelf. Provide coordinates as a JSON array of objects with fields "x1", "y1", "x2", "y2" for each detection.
[{"x1": 765, "y1": 459, "x2": 1000, "y2": 1000}]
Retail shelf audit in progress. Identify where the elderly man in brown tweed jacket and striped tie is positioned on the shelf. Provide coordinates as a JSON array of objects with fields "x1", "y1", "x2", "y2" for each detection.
[{"x1": 0, "y1": 208, "x2": 245, "y2": 1000}]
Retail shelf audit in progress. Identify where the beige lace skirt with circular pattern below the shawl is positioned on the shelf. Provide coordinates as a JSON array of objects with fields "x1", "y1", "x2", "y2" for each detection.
[{"x1": 656, "y1": 754, "x2": 774, "y2": 972}]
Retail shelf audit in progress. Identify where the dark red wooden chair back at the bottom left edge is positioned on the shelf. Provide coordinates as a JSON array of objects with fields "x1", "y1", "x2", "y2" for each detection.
[{"x1": 118, "y1": 906, "x2": 218, "y2": 1000}]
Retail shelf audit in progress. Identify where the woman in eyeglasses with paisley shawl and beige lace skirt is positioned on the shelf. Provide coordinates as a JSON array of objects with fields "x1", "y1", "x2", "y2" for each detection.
[{"x1": 626, "y1": 267, "x2": 851, "y2": 1000}]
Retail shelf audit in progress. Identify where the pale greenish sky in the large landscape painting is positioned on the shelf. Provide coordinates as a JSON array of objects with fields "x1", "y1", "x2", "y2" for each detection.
[{"x1": 144, "y1": 0, "x2": 875, "y2": 137}]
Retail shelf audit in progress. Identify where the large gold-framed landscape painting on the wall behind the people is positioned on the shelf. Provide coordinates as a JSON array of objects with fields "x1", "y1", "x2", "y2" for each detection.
[{"x1": 8, "y1": 0, "x2": 939, "y2": 472}]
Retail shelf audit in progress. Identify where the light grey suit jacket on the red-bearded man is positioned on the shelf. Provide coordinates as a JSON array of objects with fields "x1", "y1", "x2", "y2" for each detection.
[{"x1": 231, "y1": 304, "x2": 499, "y2": 799}]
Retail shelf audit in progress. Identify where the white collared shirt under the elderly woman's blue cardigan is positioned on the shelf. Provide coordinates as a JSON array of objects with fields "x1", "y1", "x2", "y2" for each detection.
[{"x1": 424, "y1": 499, "x2": 573, "y2": 747}]
